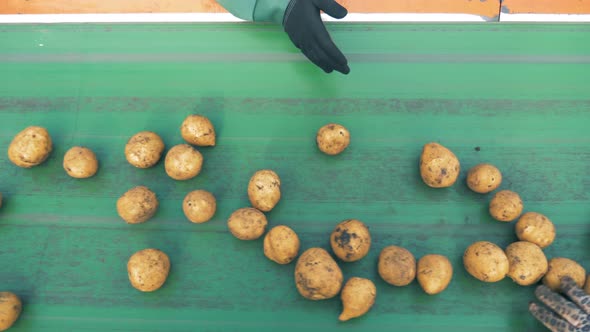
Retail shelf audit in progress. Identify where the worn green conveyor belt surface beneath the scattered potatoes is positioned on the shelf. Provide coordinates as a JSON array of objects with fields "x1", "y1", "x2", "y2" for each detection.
[{"x1": 0, "y1": 24, "x2": 590, "y2": 332}]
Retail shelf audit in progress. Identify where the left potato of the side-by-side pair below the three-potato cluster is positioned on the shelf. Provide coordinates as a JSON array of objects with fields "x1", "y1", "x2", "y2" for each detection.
[{"x1": 117, "y1": 186, "x2": 159, "y2": 224}]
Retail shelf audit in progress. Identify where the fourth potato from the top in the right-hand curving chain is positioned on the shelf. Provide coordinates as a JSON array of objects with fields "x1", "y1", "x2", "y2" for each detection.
[{"x1": 515, "y1": 212, "x2": 555, "y2": 249}]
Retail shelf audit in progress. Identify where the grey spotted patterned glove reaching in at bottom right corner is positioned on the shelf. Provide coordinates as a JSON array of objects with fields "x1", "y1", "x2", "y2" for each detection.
[{"x1": 529, "y1": 277, "x2": 590, "y2": 332}]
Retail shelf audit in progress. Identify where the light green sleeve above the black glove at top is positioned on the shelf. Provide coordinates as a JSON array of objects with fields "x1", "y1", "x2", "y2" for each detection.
[{"x1": 217, "y1": 0, "x2": 290, "y2": 24}]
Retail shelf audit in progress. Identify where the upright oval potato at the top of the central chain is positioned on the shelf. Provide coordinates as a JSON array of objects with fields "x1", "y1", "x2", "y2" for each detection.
[{"x1": 248, "y1": 169, "x2": 281, "y2": 212}]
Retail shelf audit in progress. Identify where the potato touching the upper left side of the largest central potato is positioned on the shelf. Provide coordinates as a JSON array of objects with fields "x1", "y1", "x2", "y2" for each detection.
[{"x1": 264, "y1": 225, "x2": 299, "y2": 264}]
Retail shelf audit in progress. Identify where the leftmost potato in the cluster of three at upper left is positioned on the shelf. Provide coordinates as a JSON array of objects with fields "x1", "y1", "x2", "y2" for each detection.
[{"x1": 125, "y1": 131, "x2": 165, "y2": 168}]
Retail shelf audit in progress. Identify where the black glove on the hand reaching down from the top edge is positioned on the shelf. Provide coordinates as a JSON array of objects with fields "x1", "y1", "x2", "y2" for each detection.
[{"x1": 283, "y1": 0, "x2": 350, "y2": 74}]
